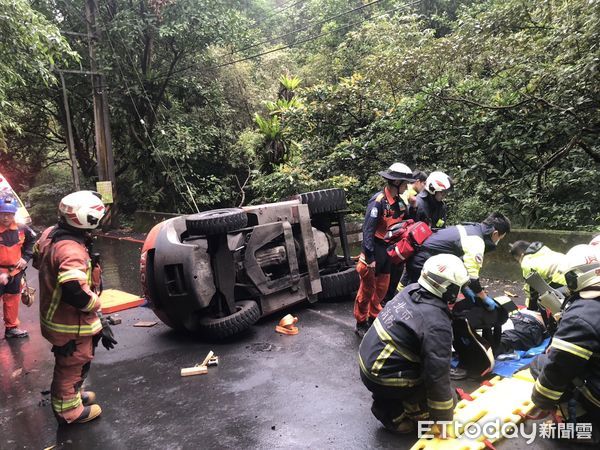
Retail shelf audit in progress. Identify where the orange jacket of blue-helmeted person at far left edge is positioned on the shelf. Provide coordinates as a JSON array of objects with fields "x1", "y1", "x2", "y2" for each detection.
[{"x1": 0, "y1": 223, "x2": 35, "y2": 275}]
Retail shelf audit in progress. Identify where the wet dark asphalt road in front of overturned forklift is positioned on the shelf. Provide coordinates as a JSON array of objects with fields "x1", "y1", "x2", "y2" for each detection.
[{"x1": 0, "y1": 246, "x2": 573, "y2": 450}]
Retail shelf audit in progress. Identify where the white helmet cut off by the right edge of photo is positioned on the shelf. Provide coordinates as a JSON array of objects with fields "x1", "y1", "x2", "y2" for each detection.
[{"x1": 564, "y1": 244, "x2": 600, "y2": 297}]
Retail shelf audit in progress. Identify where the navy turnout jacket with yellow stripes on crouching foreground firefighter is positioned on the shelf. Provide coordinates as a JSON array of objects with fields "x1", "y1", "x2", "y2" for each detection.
[{"x1": 359, "y1": 283, "x2": 454, "y2": 420}]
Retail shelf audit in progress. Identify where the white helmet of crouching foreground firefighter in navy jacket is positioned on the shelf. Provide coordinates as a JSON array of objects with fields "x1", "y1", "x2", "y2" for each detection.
[{"x1": 419, "y1": 253, "x2": 469, "y2": 302}]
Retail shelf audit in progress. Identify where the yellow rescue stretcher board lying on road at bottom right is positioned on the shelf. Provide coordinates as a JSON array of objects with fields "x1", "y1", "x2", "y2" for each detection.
[{"x1": 411, "y1": 369, "x2": 534, "y2": 450}]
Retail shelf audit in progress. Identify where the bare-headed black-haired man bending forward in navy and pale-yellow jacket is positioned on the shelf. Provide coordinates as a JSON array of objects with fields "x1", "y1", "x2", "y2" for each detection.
[{"x1": 407, "y1": 212, "x2": 510, "y2": 310}]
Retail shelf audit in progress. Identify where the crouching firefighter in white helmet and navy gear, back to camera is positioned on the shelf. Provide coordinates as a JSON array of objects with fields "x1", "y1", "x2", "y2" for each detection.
[{"x1": 359, "y1": 254, "x2": 469, "y2": 433}]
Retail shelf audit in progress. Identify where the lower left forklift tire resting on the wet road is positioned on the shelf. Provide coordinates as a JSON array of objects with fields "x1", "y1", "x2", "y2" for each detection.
[{"x1": 198, "y1": 300, "x2": 260, "y2": 340}]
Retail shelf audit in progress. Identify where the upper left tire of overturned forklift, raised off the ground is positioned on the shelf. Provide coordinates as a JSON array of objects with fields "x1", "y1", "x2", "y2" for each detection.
[{"x1": 185, "y1": 208, "x2": 248, "y2": 235}]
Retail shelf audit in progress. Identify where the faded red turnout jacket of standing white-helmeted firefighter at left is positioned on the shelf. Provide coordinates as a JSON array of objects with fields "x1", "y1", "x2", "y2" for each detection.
[{"x1": 35, "y1": 225, "x2": 102, "y2": 346}]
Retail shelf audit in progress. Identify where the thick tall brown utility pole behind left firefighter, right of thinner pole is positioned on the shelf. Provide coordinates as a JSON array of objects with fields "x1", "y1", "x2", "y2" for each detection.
[{"x1": 85, "y1": 0, "x2": 117, "y2": 228}]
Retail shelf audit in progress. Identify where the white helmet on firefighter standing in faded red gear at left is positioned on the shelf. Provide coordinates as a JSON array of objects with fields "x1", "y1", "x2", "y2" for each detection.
[{"x1": 58, "y1": 191, "x2": 106, "y2": 230}]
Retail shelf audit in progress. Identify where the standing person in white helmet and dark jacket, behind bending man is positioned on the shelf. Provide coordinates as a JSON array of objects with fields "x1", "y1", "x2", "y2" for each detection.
[{"x1": 417, "y1": 172, "x2": 452, "y2": 229}]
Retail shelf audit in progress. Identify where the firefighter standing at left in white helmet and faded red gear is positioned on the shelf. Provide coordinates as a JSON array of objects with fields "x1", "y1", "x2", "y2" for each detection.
[{"x1": 34, "y1": 191, "x2": 117, "y2": 424}]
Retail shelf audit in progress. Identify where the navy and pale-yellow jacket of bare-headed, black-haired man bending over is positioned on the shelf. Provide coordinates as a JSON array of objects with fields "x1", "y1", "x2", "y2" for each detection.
[{"x1": 413, "y1": 223, "x2": 496, "y2": 294}]
